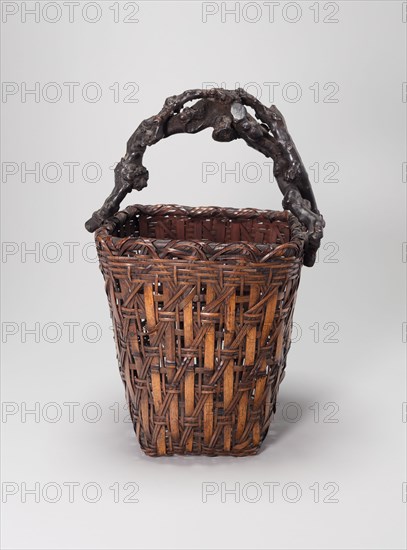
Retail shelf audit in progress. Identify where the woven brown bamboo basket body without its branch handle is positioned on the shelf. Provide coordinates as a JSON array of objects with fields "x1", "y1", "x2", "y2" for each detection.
[{"x1": 95, "y1": 205, "x2": 305, "y2": 456}]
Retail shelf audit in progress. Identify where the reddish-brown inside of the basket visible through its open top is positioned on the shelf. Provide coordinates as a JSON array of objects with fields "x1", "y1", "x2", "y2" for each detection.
[{"x1": 112, "y1": 209, "x2": 291, "y2": 245}]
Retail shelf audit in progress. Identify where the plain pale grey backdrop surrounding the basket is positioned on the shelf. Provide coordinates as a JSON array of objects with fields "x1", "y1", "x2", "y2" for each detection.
[{"x1": 1, "y1": 1, "x2": 407, "y2": 550}]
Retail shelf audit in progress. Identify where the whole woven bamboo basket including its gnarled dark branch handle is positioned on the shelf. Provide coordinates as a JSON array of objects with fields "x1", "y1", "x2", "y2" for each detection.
[{"x1": 86, "y1": 89, "x2": 324, "y2": 456}]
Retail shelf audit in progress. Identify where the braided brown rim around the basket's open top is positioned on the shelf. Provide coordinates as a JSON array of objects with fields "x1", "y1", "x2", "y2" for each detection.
[{"x1": 95, "y1": 204, "x2": 307, "y2": 263}]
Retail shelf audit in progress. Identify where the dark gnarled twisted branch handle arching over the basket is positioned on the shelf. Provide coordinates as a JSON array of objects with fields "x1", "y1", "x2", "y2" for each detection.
[{"x1": 86, "y1": 88, "x2": 325, "y2": 267}]
